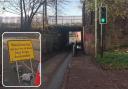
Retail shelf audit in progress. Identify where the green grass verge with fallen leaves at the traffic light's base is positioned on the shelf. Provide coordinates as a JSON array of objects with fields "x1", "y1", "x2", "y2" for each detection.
[{"x1": 96, "y1": 52, "x2": 128, "y2": 70}]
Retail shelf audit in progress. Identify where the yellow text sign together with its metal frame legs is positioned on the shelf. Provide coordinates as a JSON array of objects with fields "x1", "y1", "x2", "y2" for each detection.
[{"x1": 8, "y1": 40, "x2": 34, "y2": 84}]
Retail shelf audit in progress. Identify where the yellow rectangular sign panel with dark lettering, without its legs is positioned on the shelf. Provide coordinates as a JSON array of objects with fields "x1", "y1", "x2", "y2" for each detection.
[{"x1": 8, "y1": 40, "x2": 34, "y2": 62}]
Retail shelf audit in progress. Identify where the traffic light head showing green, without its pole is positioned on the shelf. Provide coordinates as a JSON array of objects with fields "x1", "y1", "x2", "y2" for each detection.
[{"x1": 99, "y1": 6, "x2": 107, "y2": 24}]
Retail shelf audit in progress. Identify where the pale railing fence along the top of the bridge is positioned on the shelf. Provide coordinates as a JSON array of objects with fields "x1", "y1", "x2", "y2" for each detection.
[{"x1": 0, "y1": 16, "x2": 82, "y2": 26}]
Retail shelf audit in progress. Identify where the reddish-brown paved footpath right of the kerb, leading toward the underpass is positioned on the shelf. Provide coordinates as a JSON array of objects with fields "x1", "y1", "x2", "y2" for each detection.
[{"x1": 62, "y1": 55, "x2": 128, "y2": 89}]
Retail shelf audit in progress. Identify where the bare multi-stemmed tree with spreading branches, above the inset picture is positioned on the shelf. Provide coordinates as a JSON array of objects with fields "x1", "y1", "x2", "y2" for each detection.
[{"x1": 0, "y1": 0, "x2": 45, "y2": 31}]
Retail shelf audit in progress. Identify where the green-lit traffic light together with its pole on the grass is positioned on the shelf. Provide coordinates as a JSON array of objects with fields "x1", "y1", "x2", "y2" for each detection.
[{"x1": 99, "y1": 5, "x2": 107, "y2": 57}]
